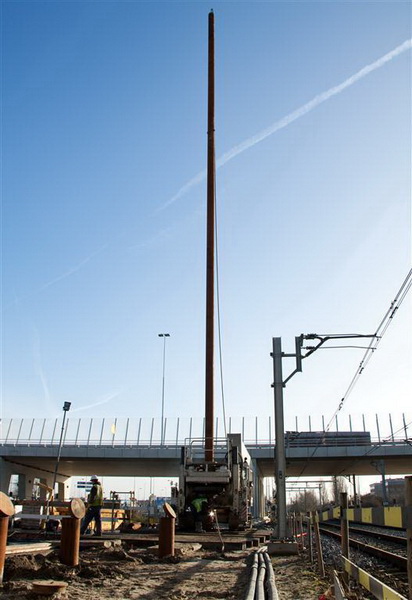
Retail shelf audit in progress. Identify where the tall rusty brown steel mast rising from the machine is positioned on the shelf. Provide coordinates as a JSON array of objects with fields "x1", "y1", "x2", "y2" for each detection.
[{"x1": 205, "y1": 11, "x2": 216, "y2": 461}]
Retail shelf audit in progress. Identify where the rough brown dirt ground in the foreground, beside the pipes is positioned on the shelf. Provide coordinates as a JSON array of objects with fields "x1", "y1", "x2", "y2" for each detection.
[{"x1": 0, "y1": 546, "x2": 328, "y2": 600}]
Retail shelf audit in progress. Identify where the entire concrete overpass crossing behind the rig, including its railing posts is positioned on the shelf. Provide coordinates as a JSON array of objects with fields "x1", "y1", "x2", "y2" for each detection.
[{"x1": 0, "y1": 419, "x2": 412, "y2": 510}]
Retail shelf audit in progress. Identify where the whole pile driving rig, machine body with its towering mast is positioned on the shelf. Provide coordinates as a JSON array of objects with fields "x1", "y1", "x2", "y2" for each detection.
[{"x1": 175, "y1": 11, "x2": 253, "y2": 530}]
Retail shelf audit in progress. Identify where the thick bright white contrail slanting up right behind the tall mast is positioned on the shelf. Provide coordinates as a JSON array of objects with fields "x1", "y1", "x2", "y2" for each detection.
[{"x1": 159, "y1": 39, "x2": 412, "y2": 210}]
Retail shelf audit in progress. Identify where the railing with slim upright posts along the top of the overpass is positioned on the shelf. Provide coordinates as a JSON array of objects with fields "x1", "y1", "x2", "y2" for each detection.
[{"x1": 0, "y1": 414, "x2": 412, "y2": 447}]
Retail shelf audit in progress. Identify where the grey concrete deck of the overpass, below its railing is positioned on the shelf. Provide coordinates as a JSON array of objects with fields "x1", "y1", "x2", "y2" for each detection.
[{"x1": 0, "y1": 440, "x2": 412, "y2": 497}]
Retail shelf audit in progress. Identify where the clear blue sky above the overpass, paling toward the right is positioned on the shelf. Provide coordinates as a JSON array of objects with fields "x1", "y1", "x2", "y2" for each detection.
[{"x1": 2, "y1": 2, "x2": 412, "y2": 452}]
